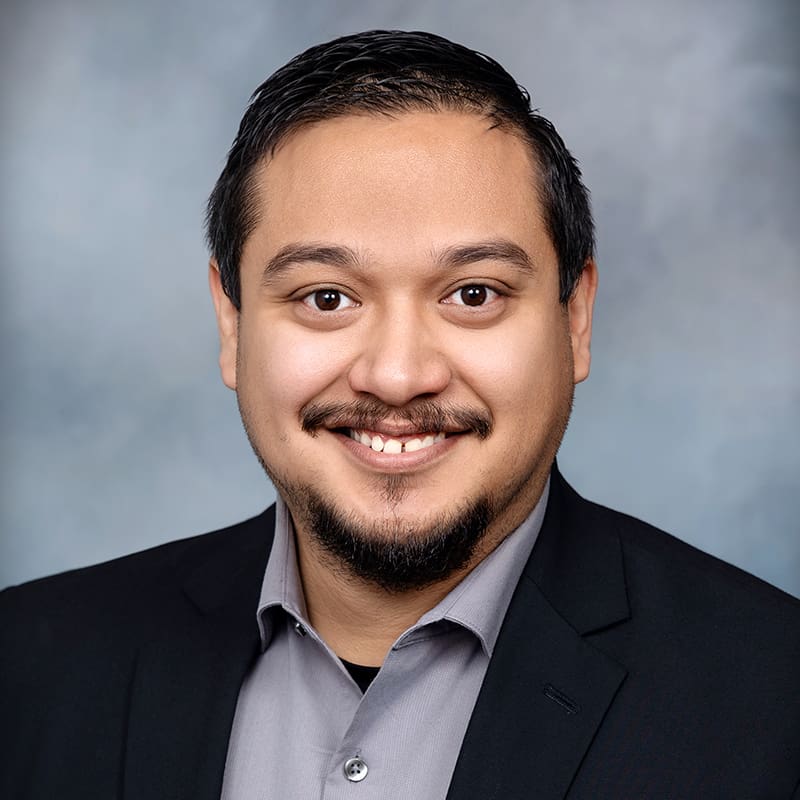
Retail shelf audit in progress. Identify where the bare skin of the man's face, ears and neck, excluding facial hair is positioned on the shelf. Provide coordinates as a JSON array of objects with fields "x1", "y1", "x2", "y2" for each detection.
[{"x1": 209, "y1": 111, "x2": 597, "y2": 664}]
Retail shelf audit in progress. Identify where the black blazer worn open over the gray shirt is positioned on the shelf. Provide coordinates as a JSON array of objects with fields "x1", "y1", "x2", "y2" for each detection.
[{"x1": 0, "y1": 471, "x2": 800, "y2": 800}]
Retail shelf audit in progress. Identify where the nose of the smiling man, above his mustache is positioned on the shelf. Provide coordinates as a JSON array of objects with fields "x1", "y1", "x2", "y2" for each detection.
[{"x1": 348, "y1": 304, "x2": 451, "y2": 408}]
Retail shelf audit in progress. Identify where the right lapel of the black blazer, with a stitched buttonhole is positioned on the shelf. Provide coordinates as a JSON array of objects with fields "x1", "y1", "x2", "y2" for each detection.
[{"x1": 448, "y1": 469, "x2": 629, "y2": 800}]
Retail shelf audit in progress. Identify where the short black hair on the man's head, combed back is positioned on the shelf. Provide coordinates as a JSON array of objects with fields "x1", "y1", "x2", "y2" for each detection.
[{"x1": 206, "y1": 31, "x2": 594, "y2": 308}]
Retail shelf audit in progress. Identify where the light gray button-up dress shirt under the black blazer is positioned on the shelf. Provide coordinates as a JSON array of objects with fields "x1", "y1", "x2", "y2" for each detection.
[{"x1": 222, "y1": 481, "x2": 550, "y2": 800}]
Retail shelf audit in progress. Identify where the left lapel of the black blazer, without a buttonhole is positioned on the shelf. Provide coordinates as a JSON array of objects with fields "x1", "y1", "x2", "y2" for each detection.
[{"x1": 123, "y1": 513, "x2": 274, "y2": 800}]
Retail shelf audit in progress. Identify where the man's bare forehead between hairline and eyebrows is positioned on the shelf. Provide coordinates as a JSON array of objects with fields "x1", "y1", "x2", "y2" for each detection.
[{"x1": 245, "y1": 111, "x2": 549, "y2": 268}]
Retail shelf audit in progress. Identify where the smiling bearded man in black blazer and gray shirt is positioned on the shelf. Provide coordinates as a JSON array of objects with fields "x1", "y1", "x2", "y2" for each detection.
[{"x1": 0, "y1": 32, "x2": 800, "y2": 800}]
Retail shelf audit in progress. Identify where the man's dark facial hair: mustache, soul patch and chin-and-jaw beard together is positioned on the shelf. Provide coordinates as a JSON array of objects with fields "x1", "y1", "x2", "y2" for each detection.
[{"x1": 239, "y1": 386, "x2": 572, "y2": 594}]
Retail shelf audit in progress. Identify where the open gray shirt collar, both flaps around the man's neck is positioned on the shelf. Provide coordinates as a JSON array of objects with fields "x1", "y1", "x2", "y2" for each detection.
[{"x1": 258, "y1": 478, "x2": 550, "y2": 657}]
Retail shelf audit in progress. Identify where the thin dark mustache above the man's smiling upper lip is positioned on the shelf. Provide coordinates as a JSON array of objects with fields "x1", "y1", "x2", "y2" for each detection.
[{"x1": 300, "y1": 398, "x2": 494, "y2": 439}]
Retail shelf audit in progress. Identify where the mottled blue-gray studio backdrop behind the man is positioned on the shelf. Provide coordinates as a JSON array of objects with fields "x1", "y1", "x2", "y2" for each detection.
[{"x1": 0, "y1": 0, "x2": 800, "y2": 594}]
